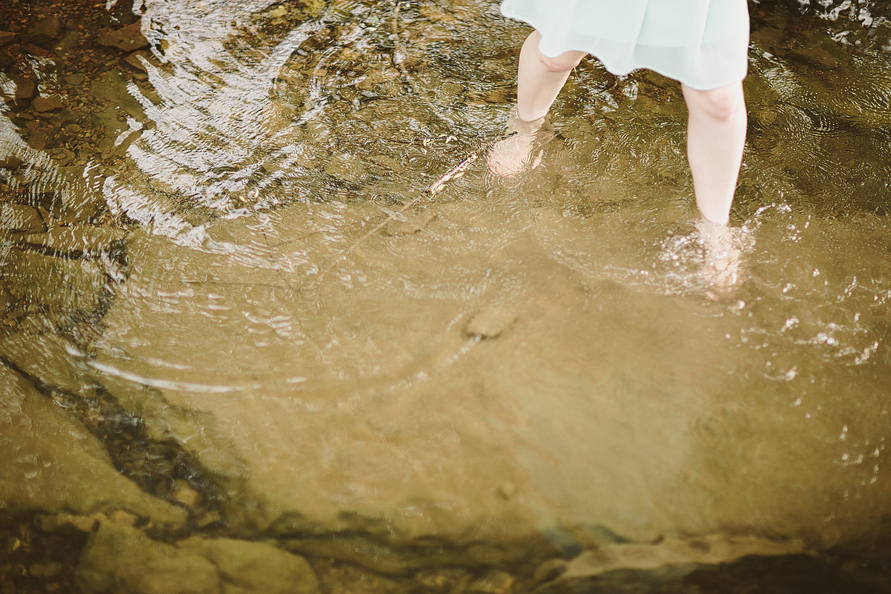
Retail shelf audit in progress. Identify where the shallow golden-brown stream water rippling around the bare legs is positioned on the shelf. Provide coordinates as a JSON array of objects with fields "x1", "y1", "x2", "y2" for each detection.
[{"x1": 0, "y1": 0, "x2": 891, "y2": 591}]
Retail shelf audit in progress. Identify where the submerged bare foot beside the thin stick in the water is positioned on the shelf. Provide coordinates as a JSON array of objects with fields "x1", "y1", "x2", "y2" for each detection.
[{"x1": 488, "y1": 108, "x2": 554, "y2": 177}]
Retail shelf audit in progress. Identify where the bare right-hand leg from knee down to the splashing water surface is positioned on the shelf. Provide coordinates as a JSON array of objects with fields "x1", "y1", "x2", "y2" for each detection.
[{"x1": 681, "y1": 82, "x2": 747, "y2": 225}]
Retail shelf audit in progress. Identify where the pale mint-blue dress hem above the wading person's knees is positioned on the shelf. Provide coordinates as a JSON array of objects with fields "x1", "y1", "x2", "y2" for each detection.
[{"x1": 501, "y1": 0, "x2": 749, "y2": 90}]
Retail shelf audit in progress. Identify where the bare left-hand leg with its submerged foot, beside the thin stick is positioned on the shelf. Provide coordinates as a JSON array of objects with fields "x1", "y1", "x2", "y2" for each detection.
[{"x1": 488, "y1": 31, "x2": 586, "y2": 176}]
